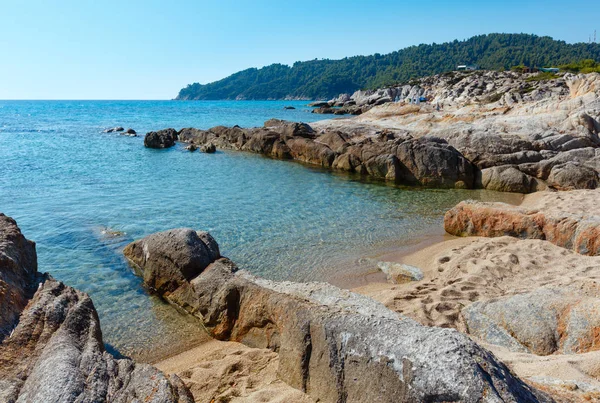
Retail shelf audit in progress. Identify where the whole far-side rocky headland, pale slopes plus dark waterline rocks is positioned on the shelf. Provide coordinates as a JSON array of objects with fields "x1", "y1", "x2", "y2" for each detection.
[{"x1": 145, "y1": 72, "x2": 600, "y2": 193}]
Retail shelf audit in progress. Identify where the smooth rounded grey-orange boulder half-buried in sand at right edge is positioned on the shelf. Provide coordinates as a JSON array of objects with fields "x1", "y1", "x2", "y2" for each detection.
[{"x1": 461, "y1": 288, "x2": 600, "y2": 355}]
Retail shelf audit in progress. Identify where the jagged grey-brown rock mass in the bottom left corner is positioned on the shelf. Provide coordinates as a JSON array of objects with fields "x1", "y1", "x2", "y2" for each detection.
[{"x1": 0, "y1": 215, "x2": 193, "y2": 403}]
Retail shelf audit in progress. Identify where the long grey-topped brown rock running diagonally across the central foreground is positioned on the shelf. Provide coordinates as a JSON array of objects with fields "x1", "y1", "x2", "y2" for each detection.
[{"x1": 125, "y1": 230, "x2": 546, "y2": 402}]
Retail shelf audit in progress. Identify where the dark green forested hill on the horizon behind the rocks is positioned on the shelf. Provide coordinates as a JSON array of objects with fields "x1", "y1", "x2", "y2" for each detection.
[{"x1": 176, "y1": 34, "x2": 600, "y2": 100}]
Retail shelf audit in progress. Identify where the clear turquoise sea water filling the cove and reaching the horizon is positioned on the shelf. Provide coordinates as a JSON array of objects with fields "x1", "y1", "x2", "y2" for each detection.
[{"x1": 0, "y1": 101, "x2": 516, "y2": 359}]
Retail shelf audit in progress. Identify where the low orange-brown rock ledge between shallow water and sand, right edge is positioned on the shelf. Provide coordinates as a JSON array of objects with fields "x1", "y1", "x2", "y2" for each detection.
[{"x1": 444, "y1": 201, "x2": 600, "y2": 256}]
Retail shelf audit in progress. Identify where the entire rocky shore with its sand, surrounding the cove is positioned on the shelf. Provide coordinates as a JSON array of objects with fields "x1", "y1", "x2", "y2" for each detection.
[{"x1": 0, "y1": 72, "x2": 600, "y2": 402}]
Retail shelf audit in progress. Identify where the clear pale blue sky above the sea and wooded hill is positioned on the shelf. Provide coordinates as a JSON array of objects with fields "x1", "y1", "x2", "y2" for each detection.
[{"x1": 0, "y1": 0, "x2": 600, "y2": 99}]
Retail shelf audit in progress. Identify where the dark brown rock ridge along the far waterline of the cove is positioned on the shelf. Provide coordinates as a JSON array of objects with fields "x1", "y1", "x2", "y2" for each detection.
[{"x1": 179, "y1": 120, "x2": 476, "y2": 189}]
